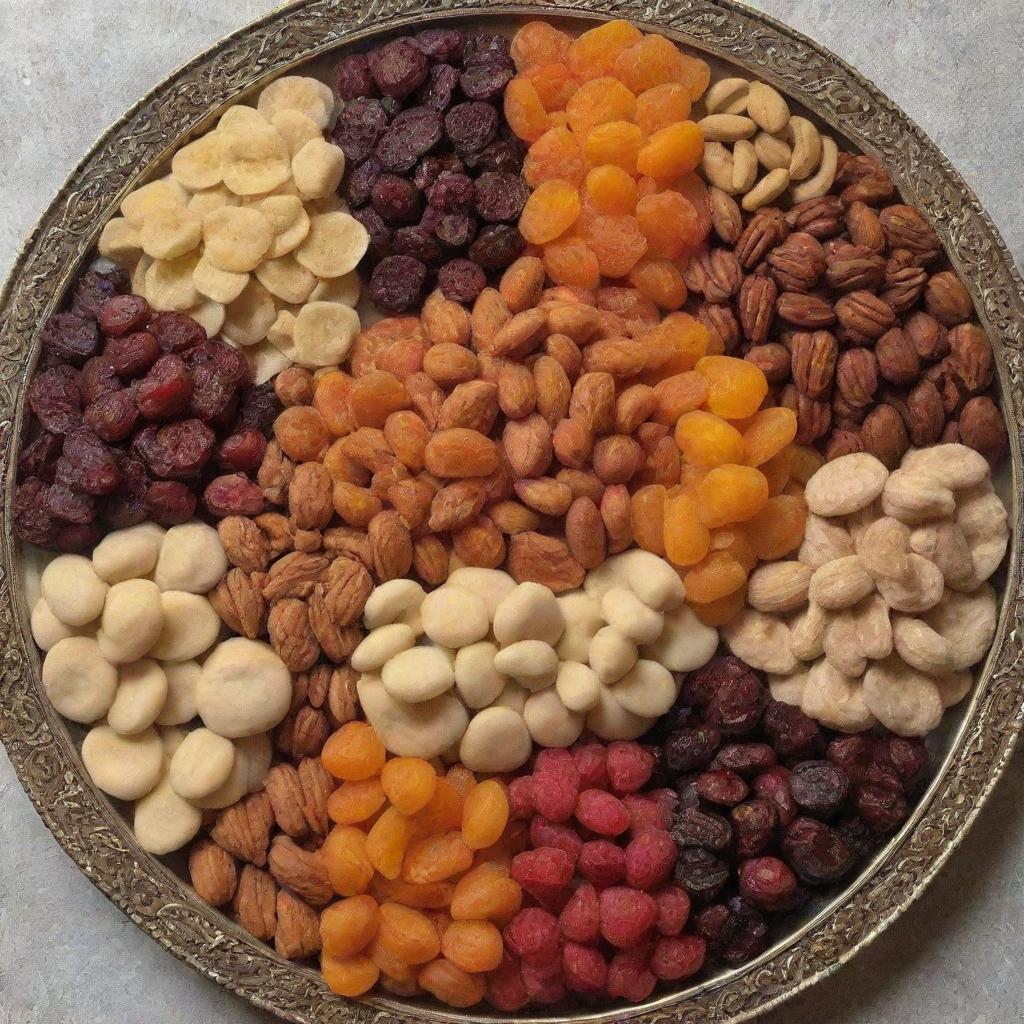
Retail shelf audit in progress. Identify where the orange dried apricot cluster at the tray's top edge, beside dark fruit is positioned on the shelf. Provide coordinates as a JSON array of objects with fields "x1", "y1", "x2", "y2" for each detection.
[{"x1": 505, "y1": 20, "x2": 711, "y2": 299}]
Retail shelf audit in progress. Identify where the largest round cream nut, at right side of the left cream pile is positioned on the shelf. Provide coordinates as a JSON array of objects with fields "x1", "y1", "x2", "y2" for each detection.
[{"x1": 196, "y1": 637, "x2": 292, "y2": 739}]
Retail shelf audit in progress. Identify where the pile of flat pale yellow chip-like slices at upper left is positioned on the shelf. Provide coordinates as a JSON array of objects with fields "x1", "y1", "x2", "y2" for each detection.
[{"x1": 99, "y1": 76, "x2": 369, "y2": 383}]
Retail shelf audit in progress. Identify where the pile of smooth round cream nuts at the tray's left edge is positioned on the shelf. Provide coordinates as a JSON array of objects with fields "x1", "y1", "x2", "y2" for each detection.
[{"x1": 32, "y1": 521, "x2": 292, "y2": 854}]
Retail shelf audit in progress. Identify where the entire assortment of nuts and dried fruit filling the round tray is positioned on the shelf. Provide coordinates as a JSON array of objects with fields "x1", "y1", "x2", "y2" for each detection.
[{"x1": 13, "y1": 12, "x2": 1010, "y2": 1013}]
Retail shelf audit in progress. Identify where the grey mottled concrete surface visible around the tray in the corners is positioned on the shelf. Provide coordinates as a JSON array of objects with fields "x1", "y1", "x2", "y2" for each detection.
[{"x1": 0, "y1": 0, "x2": 1024, "y2": 1024}]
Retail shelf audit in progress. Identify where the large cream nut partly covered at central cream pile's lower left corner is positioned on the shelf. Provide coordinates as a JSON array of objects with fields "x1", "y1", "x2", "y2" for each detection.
[{"x1": 356, "y1": 675, "x2": 468, "y2": 758}]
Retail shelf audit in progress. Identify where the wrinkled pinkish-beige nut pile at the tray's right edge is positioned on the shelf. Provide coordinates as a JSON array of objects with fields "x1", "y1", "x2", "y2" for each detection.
[{"x1": 723, "y1": 444, "x2": 1010, "y2": 736}]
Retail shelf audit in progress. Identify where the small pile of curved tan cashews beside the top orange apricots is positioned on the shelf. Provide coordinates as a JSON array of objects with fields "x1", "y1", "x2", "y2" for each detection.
[{"x1": 698, "y1": 78, "x2": 839, "y2": 211}]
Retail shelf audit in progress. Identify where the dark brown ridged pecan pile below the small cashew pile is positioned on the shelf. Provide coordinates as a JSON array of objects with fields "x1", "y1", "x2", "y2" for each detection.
[{"x1": 704, "y1": 154, "x2": 1008, "y2": 468}]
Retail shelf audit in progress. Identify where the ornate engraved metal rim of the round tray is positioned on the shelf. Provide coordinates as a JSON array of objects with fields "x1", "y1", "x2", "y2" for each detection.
[{"x1": 0, "y1": 0, "x2": 1024, "y2": 1024}]
